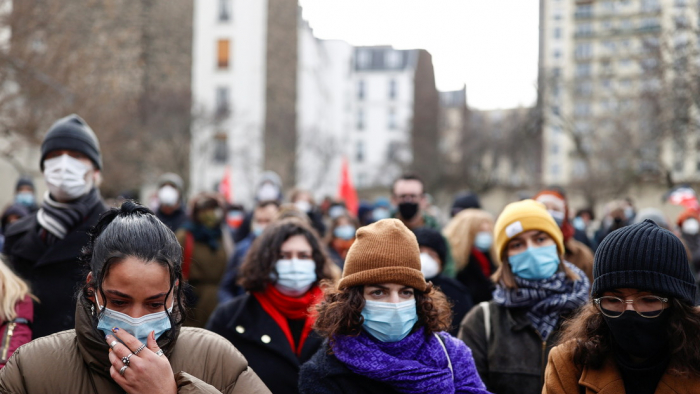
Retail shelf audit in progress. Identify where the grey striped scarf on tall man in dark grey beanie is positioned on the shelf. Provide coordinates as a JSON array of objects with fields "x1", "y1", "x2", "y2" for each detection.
[{"x1": 36, "y1": 187, "x2": 100, "y2": 245}]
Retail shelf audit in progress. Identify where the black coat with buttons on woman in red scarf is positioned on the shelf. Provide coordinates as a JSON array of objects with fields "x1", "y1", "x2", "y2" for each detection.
[{"x1": 206, "y1": 294, "x2": 323, "y2": 394}]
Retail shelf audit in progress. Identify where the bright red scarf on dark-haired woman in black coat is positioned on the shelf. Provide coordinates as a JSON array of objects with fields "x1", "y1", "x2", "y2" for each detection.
[{"x1": 253, "y1": 285, "x2": 323, "y2": 357}]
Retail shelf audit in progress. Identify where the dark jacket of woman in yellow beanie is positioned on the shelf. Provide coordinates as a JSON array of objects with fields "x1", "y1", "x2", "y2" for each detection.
[{"x1": 457, "y1": 301, "x2": 563, "y2": 394}]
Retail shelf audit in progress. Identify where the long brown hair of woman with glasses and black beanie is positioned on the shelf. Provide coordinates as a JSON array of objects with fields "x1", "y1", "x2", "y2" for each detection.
[{"x1": 559, "y1": 299, "x2": 700, "y2": 376}]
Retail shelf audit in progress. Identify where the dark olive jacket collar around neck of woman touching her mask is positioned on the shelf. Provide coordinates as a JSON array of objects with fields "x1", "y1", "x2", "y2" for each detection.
[{"x1": 75, "y1": 295, "x2": 180, "y2": 377}]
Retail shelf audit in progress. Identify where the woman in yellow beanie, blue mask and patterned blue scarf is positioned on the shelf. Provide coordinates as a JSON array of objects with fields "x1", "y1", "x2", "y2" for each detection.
[{"x1": 458, "y1": 200, "x2": 590, "y2": 394}]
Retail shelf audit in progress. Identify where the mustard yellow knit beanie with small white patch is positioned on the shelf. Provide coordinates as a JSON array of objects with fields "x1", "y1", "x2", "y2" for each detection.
[{"x1": 493, "y1": 200, "x2": 564, "y2": 261}]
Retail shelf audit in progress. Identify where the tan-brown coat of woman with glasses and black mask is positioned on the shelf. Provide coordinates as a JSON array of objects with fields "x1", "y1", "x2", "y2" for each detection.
[{"x1": 542, "y1": 342, "x2": 700, "y2": 394}]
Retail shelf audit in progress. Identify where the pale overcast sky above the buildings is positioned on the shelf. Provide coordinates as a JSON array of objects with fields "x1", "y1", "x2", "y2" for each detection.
[{"x1": 300, "y1": 0, "x2": 539, "y2": 109}]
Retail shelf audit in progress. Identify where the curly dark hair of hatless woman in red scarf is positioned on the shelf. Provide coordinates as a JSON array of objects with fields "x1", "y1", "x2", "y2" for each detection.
[{"x1": 238, "y1": 217, "x2": 332, "y2": 291}]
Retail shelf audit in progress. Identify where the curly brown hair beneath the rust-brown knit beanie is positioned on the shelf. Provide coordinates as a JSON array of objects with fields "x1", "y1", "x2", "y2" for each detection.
[{"x1": 314, "y1": 282, "x2": 452, "y2": 342}]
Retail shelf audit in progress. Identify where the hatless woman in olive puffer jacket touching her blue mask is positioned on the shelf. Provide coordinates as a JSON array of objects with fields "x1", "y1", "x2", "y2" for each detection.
[{"x1": 0, "y1": 202, "x2": 269, "y2": 394}]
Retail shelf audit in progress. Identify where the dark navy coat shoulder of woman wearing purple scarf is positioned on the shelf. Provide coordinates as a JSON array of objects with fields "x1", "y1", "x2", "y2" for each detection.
[{"x1": 299, "y1": 344, "x2": 398, "y2": 394}]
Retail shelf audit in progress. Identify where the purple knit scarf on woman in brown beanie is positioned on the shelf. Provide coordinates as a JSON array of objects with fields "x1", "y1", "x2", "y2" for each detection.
[{"x1": 333, "y1": 328, "x2": 486, "y2": 393}]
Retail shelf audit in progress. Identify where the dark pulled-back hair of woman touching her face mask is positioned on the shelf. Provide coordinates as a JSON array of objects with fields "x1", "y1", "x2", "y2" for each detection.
[{"x1": 81, "y1": 201, "x2": 186, "y2": 326}]
